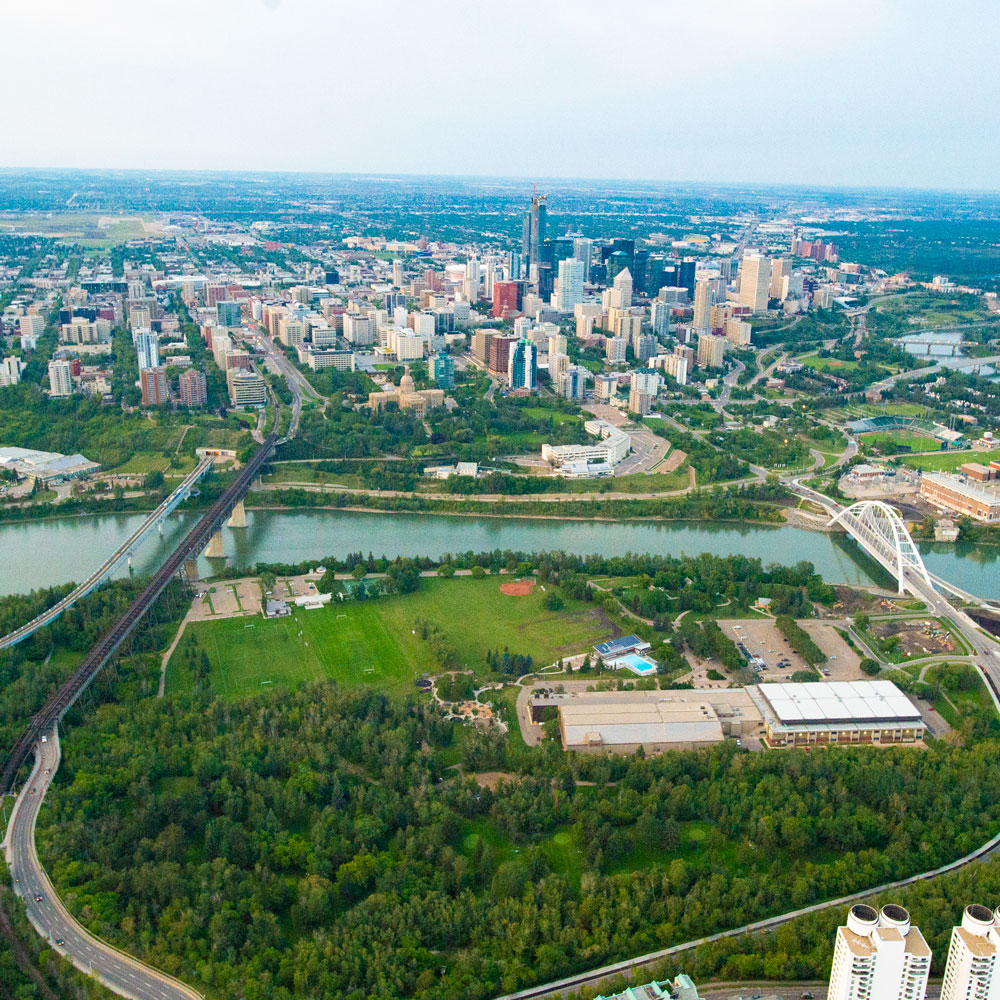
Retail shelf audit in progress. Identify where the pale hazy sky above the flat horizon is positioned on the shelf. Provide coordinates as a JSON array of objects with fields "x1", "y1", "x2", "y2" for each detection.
[{"x1": 7, "y1": 0, "x2": 1000, "y2": 189}]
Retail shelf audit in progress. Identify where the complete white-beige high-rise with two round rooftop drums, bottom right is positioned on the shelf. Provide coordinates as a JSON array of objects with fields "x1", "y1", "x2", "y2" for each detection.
[{"x1": 827, "y1": 903, "x2": 931, "y2": 1000}]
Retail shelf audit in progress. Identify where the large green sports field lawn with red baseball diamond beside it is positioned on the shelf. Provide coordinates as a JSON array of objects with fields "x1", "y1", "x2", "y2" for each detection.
[{"x1": 167, "y1": 577, "x2": 611, "y2": 698}]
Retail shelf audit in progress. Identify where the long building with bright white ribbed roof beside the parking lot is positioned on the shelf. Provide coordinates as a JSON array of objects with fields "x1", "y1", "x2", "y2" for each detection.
[{"x1": 747, "y1": 681, "x2": 926, "y2": 747}]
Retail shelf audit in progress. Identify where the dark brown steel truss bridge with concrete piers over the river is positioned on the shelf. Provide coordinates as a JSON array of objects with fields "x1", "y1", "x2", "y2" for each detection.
[{"x1": 0, "y1": 433, "x2": 277, "y2": 795}]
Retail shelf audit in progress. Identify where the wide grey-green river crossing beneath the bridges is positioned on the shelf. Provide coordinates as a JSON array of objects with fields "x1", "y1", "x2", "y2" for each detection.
[{"x1": 0, "y1": 510, "x2": 1000, "y2": 598}]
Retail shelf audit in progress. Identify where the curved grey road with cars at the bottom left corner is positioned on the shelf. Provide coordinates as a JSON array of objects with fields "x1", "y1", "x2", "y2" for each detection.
[{"x1": 5, "y1": 731, "x2": 201, "y2": 1000}]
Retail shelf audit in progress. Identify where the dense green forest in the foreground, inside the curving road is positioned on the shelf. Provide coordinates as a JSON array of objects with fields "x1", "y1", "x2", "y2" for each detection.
[{"x1": 31, "y1": 672, "x2": 1000, "y2": 1000}]
